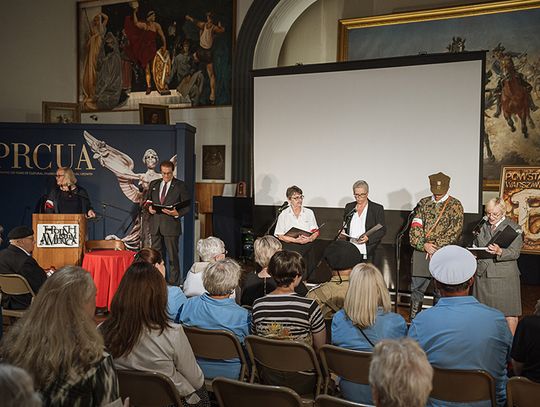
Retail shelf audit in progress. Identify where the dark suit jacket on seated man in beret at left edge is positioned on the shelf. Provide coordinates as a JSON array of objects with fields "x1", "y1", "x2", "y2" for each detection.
[{"x1": 0, "y1": 245, "x2": 47, "y2": 309}]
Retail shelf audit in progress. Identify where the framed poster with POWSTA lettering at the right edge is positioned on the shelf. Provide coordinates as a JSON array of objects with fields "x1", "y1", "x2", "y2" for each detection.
[{"x1": 501, "y1": 167, "x2": 540, "y2": 254}]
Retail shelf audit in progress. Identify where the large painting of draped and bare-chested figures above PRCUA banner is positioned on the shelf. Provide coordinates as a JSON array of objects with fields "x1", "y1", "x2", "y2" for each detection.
[{"x1": 77, "y1": 0, "x2": 236, "y2": 112}]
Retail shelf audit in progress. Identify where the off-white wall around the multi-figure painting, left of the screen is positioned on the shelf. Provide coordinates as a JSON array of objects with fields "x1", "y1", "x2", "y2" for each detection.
[{"x1": 0, "y1": 0, "x2": 253, "y2": 181}]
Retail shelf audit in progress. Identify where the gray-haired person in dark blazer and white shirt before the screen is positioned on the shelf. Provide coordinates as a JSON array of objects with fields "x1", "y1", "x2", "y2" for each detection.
[{"x1": 343, "y1": 181, "x2": 386, "y2": 263}]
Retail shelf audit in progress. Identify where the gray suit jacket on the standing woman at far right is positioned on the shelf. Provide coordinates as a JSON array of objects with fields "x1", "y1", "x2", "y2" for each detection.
[{"x1": 474, "y1": 218, "x2": 523, "y2": 278}]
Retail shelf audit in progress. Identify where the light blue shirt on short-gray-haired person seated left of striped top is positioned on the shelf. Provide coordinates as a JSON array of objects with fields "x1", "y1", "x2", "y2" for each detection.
[{"x1": 178, "y1": 294, "x2": 251, "y2": 379}]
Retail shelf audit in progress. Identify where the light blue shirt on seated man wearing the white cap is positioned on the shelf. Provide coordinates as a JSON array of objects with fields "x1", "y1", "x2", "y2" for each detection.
[{"x1": 409, "y1": 296, "x2": 512, "y2": 406}]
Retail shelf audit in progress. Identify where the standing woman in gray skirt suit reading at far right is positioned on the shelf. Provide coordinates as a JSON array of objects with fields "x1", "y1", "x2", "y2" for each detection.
[{"x1": 473, "y1": 198, "x2": 523, "y2": 335}]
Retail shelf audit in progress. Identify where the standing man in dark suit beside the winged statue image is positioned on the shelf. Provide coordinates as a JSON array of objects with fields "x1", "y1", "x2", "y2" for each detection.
[{"x1": 147, "y1": 161, "x2": 190, "y2": 285}]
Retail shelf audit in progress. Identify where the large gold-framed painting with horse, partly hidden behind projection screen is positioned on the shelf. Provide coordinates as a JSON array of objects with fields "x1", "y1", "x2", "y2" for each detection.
[{"x1": 338, "y1": 0, "x2": 540, "y2": 190}]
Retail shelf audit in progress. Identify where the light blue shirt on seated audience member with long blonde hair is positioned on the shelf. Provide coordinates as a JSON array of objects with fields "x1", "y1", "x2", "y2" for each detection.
[{"x1": 332, "y1": 308, "x2": 407, "y2": 404}]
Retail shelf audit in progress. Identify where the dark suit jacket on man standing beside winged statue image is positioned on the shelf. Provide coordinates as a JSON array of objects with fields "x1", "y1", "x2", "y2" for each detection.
[{"x1": 146, "y1": 178, "x2": 190, "y2": 236}]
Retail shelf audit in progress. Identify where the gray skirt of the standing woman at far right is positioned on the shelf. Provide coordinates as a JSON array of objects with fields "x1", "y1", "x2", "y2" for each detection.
[{"x1": 473, "y1": 273, "x2": 521, "y2": 317}]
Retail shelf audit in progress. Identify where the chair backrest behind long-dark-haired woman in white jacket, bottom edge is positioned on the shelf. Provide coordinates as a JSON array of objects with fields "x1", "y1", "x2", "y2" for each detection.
[{"x1": 117, "y1": 370, "x2": 182, "y2": 407}]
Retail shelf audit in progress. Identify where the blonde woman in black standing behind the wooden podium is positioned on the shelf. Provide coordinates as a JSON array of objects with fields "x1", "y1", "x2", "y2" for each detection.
[{"x1": 45, "y1": 167, "x2": 96, "y2": 218}]
